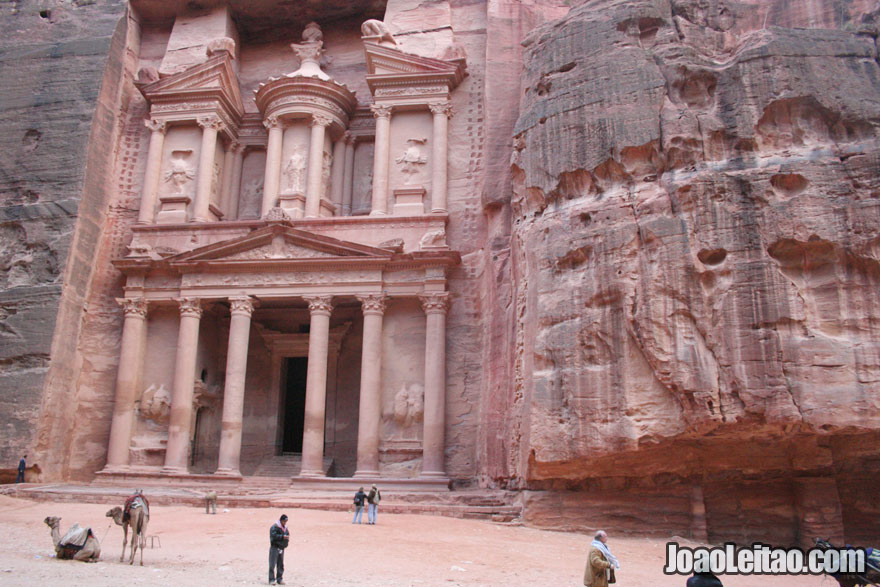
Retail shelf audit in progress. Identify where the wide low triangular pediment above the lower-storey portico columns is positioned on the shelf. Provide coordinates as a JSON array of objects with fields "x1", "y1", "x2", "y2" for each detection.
[{"x1": 168, "y1": 224, "x2": 393, "y2": 265}]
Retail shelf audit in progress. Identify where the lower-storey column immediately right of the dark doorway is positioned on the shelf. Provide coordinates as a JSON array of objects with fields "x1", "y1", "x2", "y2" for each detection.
[{"x1": 300, "y1": 296, "x2": 333, "y2": 477}]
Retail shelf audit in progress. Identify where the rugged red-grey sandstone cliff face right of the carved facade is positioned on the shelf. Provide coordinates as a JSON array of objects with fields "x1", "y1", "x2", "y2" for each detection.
[{"x1": 502, "y1": 0, "x2": 880, "y2": 541}]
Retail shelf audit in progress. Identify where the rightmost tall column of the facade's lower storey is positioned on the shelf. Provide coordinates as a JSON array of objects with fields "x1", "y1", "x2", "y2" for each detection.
[{"x1": 419, "y1": 292, "x2": 449, "y2": 477}]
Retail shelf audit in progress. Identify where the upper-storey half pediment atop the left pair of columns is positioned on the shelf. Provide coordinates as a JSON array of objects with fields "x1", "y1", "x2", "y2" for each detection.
[{"x1": 140, "y1": 52, "x2": 244, "y2": 116}]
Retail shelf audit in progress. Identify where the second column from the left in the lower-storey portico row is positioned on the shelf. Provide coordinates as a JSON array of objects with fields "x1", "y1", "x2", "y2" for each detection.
[{"x1": 162, "y1": 298, "x2": 202, "y2": 473}]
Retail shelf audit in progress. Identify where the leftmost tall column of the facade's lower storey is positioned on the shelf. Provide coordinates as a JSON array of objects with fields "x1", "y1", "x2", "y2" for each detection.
[{"x1": 104, "y1": 298, "x2": 147, "y2": 471}]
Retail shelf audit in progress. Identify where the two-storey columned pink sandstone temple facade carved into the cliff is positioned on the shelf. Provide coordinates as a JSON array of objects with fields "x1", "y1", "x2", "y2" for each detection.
[{"x1": 99, "y1": 7, "x2": 467, "y2": 487}]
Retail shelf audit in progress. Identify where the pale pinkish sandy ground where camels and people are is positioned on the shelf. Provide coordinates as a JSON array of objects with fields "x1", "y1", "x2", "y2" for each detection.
[{"x1": 0, "y1": 495, "x2": 836, "y2": 587}]
